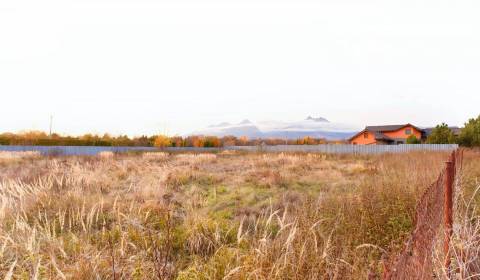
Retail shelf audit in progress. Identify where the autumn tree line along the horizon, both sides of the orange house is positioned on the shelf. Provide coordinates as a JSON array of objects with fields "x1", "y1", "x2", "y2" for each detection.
[{"x1": 0, "y1": 115, "x2": 480, "y2": 148}]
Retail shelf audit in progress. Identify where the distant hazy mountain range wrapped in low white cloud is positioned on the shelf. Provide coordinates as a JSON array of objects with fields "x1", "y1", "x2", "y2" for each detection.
[{"x1": 191, "y1": 116, "x2": 360, "y2": 140}]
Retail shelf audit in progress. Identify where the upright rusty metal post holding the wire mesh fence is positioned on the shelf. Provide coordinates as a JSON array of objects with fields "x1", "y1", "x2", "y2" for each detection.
[{"x1": 443, "y1": 152, "x2": 455, "y2": 274}]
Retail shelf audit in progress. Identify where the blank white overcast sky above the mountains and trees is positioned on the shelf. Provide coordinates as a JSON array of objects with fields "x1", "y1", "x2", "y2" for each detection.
[{"x1": 0, "y1": 0, "x2": 480, "y2": 135}]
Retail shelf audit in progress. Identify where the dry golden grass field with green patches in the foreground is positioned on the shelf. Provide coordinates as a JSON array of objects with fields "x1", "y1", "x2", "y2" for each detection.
[{"x1": 0, "y1": 152, "x2": 480, "y2": 280}]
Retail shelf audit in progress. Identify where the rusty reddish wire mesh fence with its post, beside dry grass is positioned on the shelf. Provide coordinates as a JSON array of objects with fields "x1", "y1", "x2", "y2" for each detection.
[{"x1": 383, "y1": 149, "x2": 463, "y2": 280}]
